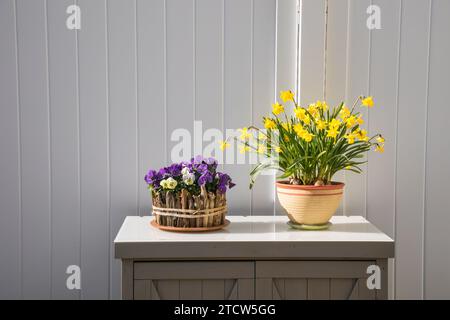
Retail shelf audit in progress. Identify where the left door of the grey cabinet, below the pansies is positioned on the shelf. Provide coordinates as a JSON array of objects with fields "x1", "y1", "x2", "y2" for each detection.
[{"x1": 134, "y1": 262, "x2": 254, "y2": 300}]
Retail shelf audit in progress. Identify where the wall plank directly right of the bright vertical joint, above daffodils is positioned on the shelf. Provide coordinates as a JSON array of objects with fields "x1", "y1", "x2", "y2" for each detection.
[{"x1": 300, "y1": 0, "x2": 326, "y2": 106}]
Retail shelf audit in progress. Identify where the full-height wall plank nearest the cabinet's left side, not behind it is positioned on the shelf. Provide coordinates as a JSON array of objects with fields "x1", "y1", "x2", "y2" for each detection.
[{"x1": 78, "y1": 0, "x2": 110, "y2": 299}]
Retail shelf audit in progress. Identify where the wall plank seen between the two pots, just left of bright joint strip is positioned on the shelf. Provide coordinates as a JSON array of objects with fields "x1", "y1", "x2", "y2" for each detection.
[{"x1": 251, "y1": 0, "x2": 276, "y2": 215}]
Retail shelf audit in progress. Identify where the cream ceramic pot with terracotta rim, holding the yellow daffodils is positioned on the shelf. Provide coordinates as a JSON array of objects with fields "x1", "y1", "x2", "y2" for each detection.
[{"x1": 277, "y1": 181, "x2": 344, "y2": 226}]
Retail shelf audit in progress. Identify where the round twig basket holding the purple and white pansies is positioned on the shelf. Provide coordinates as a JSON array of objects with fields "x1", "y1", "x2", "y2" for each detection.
[{"x1": 153, "y1": 205, "x2": 227, "y2": 228}]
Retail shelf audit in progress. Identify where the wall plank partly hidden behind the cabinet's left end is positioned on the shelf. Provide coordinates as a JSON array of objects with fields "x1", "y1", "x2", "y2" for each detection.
[{"x1": 108, "y1": 0, "x2": 138, "y2": 299}]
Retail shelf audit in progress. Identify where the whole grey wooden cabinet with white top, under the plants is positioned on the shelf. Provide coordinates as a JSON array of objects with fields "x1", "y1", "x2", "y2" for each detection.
[{"x1": 114, "y1": 216, "x2": 394, "y2": 300}]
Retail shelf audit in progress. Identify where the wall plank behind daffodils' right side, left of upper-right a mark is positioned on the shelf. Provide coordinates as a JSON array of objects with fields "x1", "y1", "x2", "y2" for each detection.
[{"x1": 344, "y1": 0, "x2": 370, "y2": 216}]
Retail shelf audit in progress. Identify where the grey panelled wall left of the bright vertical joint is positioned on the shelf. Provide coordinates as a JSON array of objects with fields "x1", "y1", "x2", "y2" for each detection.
[{"x1": 0, "y1": 0, "x2": 296, "y2": 299}]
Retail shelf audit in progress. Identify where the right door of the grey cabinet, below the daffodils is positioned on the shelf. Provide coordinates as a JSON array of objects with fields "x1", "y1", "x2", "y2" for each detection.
[{"x1": 256, "y1": 261, "x2": 377, "y2": 300}]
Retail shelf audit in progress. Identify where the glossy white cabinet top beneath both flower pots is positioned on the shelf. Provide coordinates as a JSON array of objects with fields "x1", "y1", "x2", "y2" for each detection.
[{"x1": 114, "y1": 216, "x2": 394, "y2": 259}]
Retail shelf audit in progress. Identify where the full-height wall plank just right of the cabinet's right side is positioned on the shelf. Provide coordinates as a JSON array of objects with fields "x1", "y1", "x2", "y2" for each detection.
[{"x1": 396, "y1": 0, "x2": 430, "y2": 299}]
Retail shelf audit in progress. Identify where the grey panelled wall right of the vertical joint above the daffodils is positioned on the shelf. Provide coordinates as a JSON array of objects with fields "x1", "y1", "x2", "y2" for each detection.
[{"x1": 310, "y1": 0, "x2": 450, "y2": 299}]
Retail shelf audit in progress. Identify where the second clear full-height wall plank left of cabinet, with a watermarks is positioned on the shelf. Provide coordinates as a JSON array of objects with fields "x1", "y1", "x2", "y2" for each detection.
[{"x1": 47, "y1": 0, "x2": 81, "y2": 299}]
